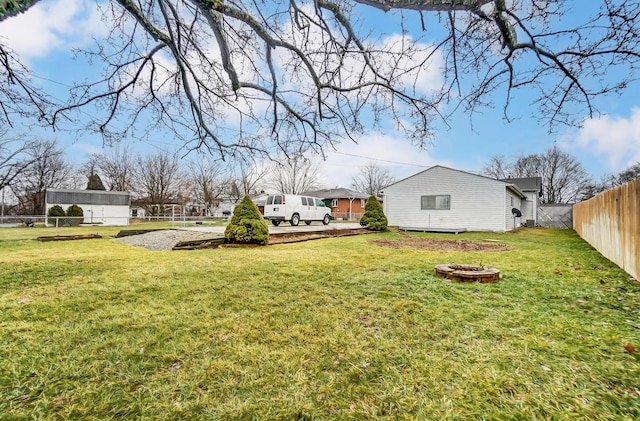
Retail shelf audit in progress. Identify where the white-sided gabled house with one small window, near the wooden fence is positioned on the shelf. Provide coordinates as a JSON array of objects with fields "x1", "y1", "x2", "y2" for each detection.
[{"x1": 383, "y1": 165, "x2": 537, "y2": 232}]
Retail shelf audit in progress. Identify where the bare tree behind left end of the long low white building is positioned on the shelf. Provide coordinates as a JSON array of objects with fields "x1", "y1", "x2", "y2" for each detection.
[{"x1": 11, "y1": 140, "x2": 72, "y2": 215}]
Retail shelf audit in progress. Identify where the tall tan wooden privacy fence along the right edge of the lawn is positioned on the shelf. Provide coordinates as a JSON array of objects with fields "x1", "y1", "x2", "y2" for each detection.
[{"x1": 573, "y1": 179, "x2": 640, "y2": 280}]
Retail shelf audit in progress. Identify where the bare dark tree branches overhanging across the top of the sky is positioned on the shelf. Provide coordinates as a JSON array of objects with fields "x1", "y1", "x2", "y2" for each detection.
[{"x1": 0, "y1": 0, "x2": 640, "y2": 157}]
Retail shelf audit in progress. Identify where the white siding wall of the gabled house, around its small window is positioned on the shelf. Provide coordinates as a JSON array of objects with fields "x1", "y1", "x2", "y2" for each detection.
[{"x1": 383, "y1": 166, "x2": 513, "y2": 231}]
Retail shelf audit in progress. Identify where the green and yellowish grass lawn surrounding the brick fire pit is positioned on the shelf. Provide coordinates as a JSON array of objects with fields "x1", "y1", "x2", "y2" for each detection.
[{"x1": 0, "y1": 227, "x2": 640, "y2": 420}]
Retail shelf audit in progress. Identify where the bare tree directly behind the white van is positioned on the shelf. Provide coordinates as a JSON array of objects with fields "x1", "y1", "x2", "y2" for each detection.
[{"x1": 267, "y1": 156, "x2": 320, "y2": 194}]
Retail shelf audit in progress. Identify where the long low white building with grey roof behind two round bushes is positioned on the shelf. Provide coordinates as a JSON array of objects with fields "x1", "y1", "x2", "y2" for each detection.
[{"x1": 45, "y1": 189, "x2": 131, "y2": 225}]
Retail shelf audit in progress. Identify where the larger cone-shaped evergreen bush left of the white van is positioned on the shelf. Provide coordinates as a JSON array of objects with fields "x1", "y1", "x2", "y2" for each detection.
[{"x1": 224, "y1": 195, "x2": 269, "y2": 244}]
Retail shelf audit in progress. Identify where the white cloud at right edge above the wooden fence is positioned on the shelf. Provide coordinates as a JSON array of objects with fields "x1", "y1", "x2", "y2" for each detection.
[{"x1": 569, "y1": 108, "x2": 640, "y2": 171}]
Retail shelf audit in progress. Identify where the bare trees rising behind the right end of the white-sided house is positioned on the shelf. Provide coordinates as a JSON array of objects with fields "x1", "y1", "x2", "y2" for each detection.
[{"x1": 482, "y1": 146, "x2": 593, "y2": 203}]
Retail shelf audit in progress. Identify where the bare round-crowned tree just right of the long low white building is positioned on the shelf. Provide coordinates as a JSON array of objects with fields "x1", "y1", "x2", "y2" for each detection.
[{"x1": 134, "y1": 153, "x2": 183, "y2": 215}]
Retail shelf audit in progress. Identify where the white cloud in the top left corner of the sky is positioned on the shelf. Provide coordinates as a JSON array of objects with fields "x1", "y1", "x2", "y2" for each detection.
[{"x1": 0, "y1": 0, "x2": 106, "y2": 60}]
